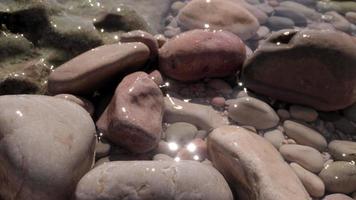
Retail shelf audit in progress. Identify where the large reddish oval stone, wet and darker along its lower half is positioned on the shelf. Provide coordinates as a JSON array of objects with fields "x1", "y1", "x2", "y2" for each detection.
[{"x1": 159, "y1": 30, "x2": 246, "y2": 81}]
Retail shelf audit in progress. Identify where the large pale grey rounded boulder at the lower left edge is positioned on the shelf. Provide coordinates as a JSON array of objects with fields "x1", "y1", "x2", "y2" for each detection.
[{"x1": 0, "y1": 95, "x2": 95, "y2": 200}]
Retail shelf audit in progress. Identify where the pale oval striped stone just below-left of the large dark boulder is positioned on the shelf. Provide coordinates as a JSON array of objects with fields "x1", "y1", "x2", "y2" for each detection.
[{"x1": 228, "y1": 97, "x2": 279, "y2": 129}]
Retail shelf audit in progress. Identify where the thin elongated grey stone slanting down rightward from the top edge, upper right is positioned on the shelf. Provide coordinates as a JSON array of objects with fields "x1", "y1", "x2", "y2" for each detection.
[{"x1": 279, "y1": 1, "x2": 321, "y2": 21}]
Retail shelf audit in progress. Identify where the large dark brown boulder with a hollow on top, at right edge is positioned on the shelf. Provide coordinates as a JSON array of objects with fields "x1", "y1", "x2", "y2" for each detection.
[{"x1": 242, "y1": 29, "x2": 356, "y2": 111}]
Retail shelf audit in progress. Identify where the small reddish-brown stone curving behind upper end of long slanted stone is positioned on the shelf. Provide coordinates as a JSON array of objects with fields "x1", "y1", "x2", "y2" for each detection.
[{"x1": 120, "y1": 30, "x2": 158, "y2": 60}]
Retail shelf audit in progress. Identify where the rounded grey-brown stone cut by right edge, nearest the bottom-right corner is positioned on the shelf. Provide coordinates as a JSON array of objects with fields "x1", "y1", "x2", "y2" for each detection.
[{"x1": 319, "y1": 161, "x2": 356, "y2": 194}]
